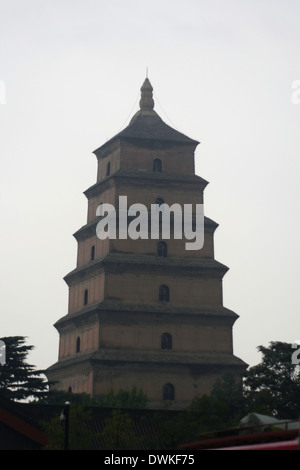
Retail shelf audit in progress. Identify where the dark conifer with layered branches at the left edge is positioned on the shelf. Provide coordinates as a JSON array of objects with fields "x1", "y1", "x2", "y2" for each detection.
[{"x1": 0, "y1": 336, "x2": 48, "y2": 401}]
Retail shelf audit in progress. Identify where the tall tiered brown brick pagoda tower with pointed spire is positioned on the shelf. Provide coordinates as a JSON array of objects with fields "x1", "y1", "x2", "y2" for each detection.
[{"x1": 47, "y1": 78, "x2": 247, "y2": 408}]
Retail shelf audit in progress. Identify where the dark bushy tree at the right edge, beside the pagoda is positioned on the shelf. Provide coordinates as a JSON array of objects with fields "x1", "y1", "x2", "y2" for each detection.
[{"x1": 244, "y1": 341, "x2": 300, "y2": 419}]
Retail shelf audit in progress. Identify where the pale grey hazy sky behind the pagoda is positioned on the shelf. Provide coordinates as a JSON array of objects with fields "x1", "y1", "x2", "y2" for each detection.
[{"x1": 0, "y1": 0, "x2": 300, "y2": 374}]
